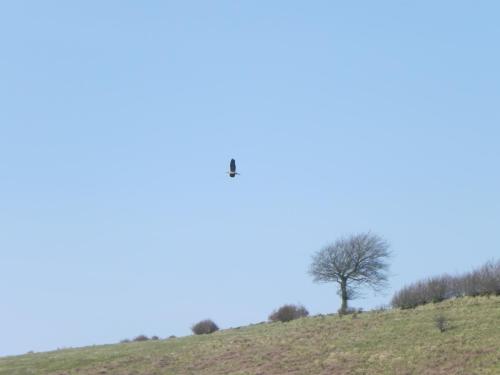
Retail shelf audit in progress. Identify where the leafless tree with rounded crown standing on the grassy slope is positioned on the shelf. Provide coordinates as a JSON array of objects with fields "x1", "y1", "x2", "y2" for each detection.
[{"x1": 309, "y1": 233, "x2": 391, "y2": 313}]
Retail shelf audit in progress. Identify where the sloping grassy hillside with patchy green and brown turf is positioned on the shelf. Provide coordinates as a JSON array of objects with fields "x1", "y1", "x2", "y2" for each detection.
[{"x1": 0, "y1": 297, "x2": 500, "y2": 375}]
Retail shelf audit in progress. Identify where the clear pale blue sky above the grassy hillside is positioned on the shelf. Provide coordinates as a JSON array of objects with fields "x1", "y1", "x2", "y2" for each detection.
[{"x1": 0, "y1": 0, "x2": 500, "y2": 355}]
